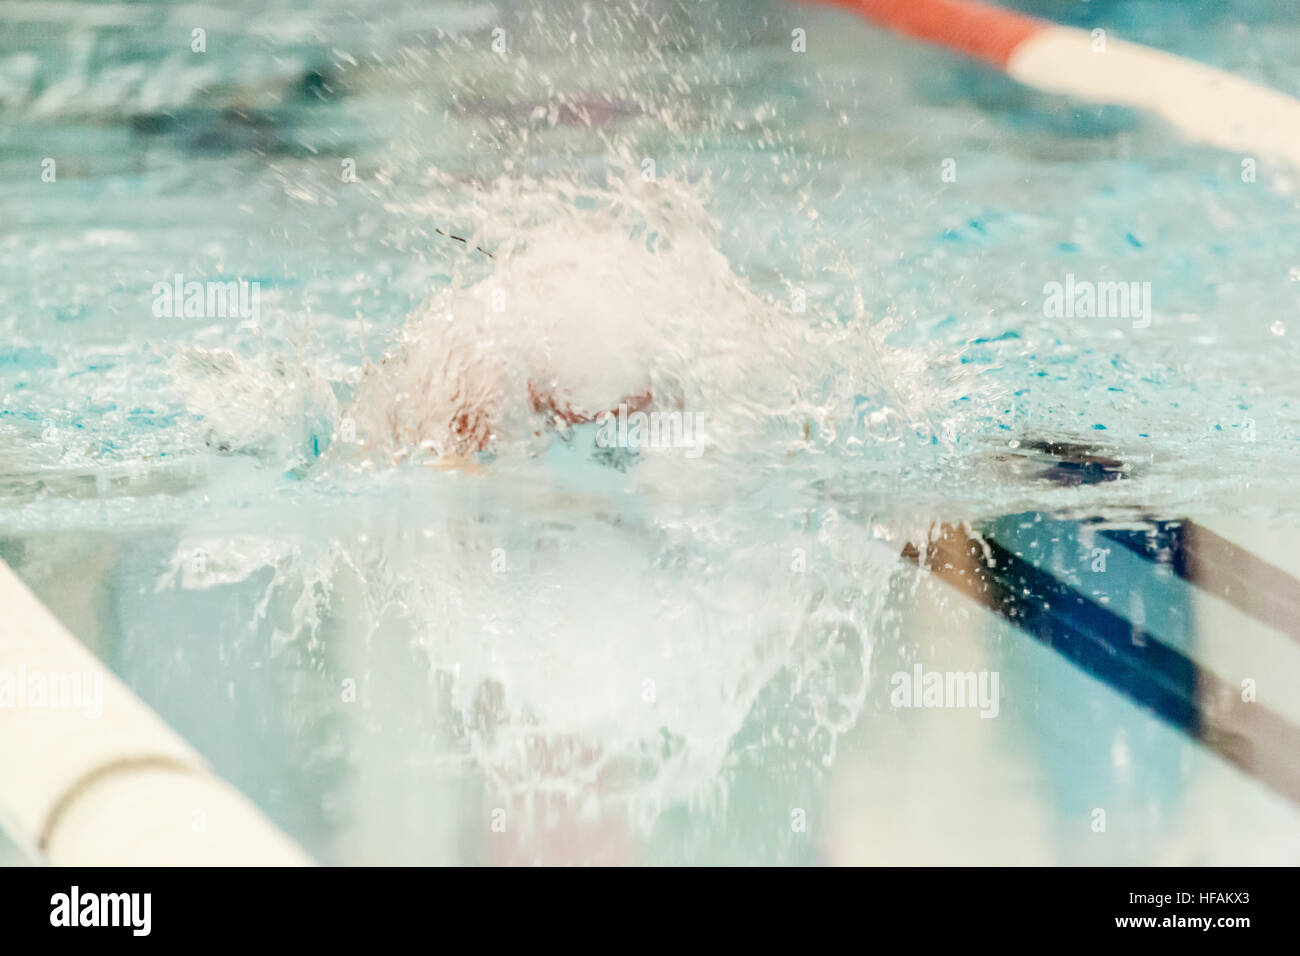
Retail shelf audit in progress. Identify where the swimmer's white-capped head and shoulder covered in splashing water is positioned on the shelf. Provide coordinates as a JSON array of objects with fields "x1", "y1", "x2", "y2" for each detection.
[{"x1": 330, "y1": 228, "x2": 716, "y2": 472}]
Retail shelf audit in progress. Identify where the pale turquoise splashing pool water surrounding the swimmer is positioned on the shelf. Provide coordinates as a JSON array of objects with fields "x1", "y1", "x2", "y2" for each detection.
[{"x1": 0, "y1": 0, "x2": 1300, "y2": 864}]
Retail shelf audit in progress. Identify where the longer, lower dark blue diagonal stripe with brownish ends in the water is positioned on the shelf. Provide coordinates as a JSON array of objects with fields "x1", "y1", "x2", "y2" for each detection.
[{"x1": 904, "y1": 527, "x2": 1300, "y2": 804}]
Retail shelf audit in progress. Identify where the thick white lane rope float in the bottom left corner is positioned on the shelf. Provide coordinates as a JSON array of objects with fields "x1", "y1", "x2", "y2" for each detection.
[{"x1": 0, "y1": 562, "x2": 311, "y2": 866}]
